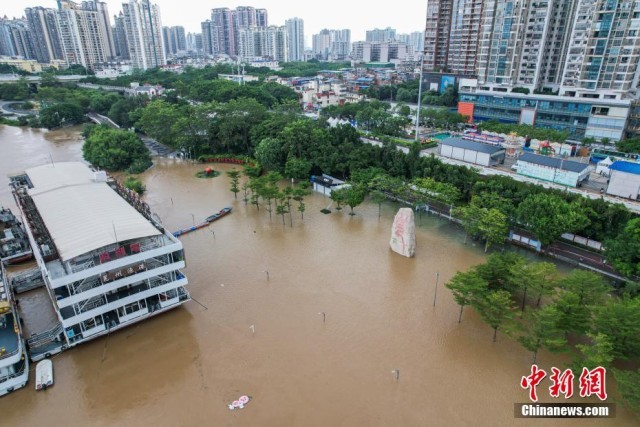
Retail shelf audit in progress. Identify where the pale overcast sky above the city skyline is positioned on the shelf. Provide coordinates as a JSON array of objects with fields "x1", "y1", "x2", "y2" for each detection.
[{"x1": 5, "y1": 0, "x2": 427, "y2": 45}]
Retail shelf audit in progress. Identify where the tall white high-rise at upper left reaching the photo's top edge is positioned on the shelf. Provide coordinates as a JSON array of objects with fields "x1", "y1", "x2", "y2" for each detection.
[{"x1": 122, "y1": 0, "x2": 167, "y2": 70}]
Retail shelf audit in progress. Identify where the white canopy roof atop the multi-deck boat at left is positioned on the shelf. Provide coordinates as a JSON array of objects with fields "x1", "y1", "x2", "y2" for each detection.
[{"x1": 26, "y1": 162, "x2": 161, "y2": 261}]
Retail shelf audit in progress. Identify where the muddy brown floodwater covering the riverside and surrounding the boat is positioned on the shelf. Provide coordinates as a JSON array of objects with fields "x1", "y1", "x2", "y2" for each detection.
[{"x1": 0, "y1": 126, "x2": 638, "y2": 426}]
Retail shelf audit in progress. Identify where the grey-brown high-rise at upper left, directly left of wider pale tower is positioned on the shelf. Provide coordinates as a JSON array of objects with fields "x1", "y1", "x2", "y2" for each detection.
[{"x1": 24, "y1": 7, "x2": 64, "y2": 63}]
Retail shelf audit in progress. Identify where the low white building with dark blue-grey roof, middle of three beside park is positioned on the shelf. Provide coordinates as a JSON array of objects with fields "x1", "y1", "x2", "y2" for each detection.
[{"x1": 517, "y1": 153, "x2": 591, "y2": 187}]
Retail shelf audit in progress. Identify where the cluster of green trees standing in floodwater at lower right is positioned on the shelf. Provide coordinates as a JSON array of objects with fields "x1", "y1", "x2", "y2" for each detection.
[{"x1": 446, "y1": 253, "x2": 640, "y2": 410}]
